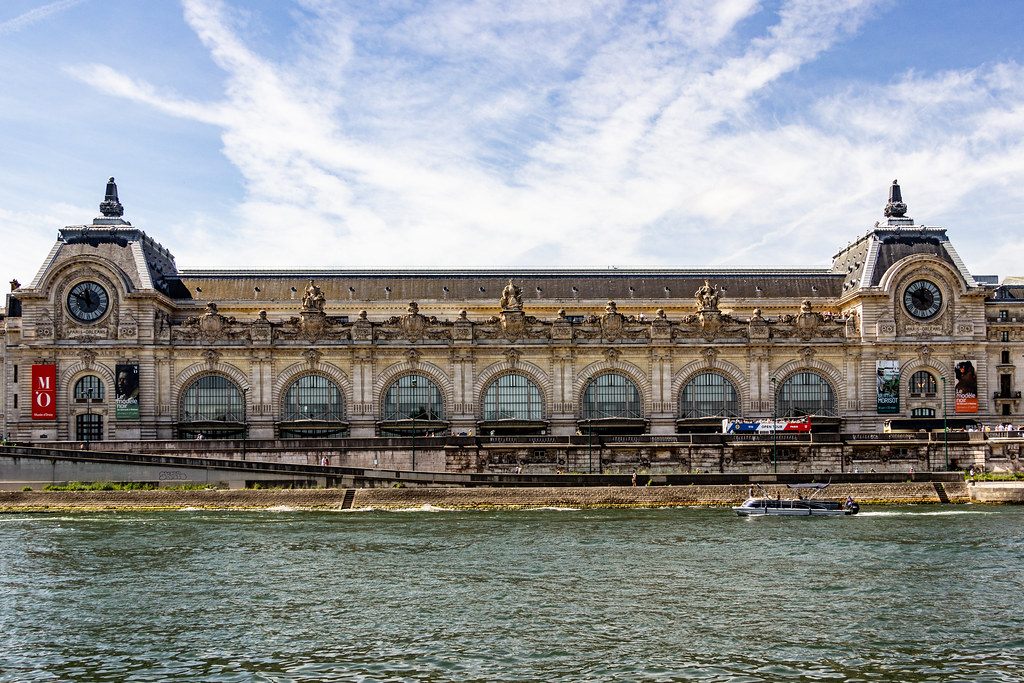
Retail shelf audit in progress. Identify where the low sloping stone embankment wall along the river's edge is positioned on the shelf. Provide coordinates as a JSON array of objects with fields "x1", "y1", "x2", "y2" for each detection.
[{"x1": 0, "y1": 482, "x2": 971, "y2": 512}]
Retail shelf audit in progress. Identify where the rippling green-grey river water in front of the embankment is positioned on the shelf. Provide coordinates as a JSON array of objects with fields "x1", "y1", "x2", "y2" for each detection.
[{"x1": 0, "y1": 506, "x2": 1024, "y2": 681}]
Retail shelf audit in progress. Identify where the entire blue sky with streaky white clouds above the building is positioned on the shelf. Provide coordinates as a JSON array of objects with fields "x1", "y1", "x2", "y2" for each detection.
[{"x1": 0, "y1": 0, "x2": 1024, "y2": 290}]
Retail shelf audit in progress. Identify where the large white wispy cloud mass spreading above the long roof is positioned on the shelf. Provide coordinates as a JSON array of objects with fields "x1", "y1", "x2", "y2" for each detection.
[{"x1": 61, "y1": 0, "x2": 1024, "y2": 274}]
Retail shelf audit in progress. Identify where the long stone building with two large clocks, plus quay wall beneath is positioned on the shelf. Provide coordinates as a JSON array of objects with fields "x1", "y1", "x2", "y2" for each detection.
[{"x1": 6, "y1": 178, "x2": 1024, "y2": 472}]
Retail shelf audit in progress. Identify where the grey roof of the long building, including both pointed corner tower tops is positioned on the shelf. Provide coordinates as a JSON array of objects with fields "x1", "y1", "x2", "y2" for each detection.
[{"x1": 22, "y1": 177, "x2": 981, "y2": 303}]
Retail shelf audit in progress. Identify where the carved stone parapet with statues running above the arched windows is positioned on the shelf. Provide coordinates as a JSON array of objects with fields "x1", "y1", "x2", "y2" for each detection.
[{"x1": 130, "y1": 283, "x2": 872, "y2": 352}]
